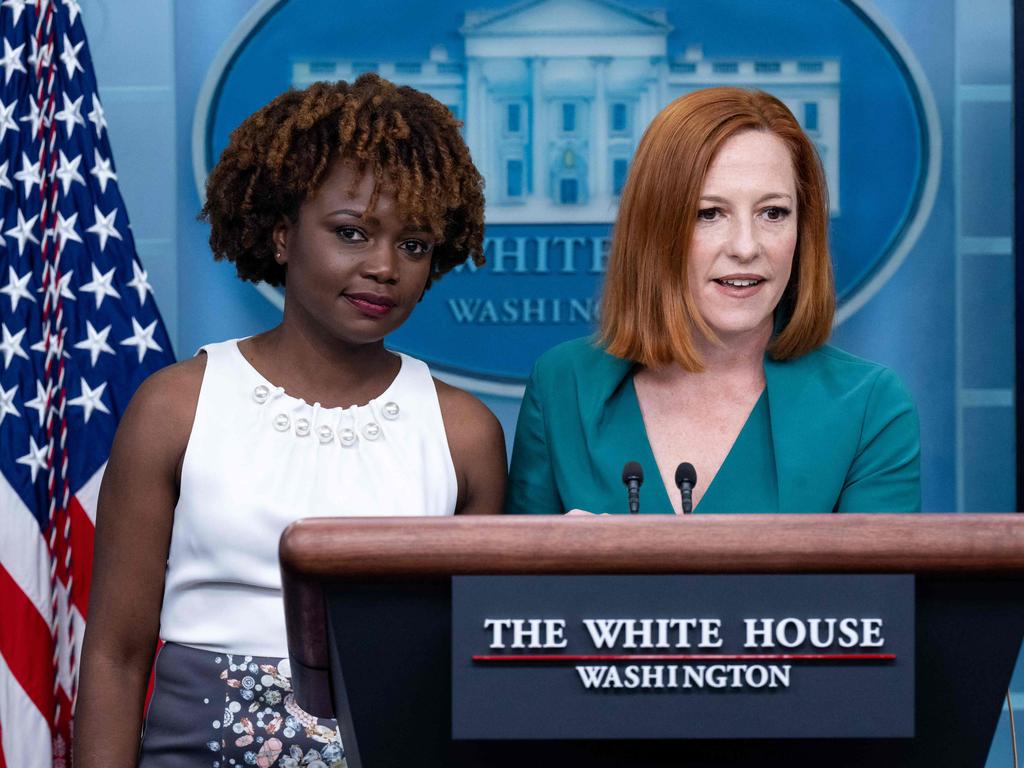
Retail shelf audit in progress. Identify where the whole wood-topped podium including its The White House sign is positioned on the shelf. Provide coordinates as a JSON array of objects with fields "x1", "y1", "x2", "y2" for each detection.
[{"x1": 281, "y1": 514, "x2": 1024, "y2": 768}]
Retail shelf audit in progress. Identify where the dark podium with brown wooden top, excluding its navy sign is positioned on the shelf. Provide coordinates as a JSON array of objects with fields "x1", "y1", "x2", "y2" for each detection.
[{"x1": 281, "y1": 514, "x2": 1024, "y2": 768}]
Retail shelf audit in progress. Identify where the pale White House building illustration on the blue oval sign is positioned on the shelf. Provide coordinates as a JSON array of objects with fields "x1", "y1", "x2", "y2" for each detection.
[{"x1": 292, "y1": 0, "x2": 840, "y2": 224}]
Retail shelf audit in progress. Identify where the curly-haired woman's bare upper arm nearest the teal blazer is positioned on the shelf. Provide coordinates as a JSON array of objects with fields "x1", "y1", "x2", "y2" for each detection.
[{"x1": 435, "y1": 380, "x2": 508, "y2": 515}]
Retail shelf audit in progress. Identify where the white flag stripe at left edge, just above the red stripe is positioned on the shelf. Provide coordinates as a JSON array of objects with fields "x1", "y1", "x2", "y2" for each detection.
[{"x1": 0, "y1": 473, "x2": 52, "y2": 626}]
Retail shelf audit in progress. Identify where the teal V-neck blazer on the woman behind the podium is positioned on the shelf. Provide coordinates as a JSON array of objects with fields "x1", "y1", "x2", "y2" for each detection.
[{"x1": 506, "y1": 339, "x2": 921, "y2": 514}]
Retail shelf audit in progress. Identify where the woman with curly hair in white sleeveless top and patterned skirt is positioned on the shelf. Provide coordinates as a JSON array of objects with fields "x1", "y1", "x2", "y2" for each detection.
[{"x1": 75, "y1": 75, "x2": 505, "y2": 768}]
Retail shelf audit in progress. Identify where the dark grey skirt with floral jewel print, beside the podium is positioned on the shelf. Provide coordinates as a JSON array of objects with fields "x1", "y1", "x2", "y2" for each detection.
[{"x1": 139, "y1": 643, "x2": 346, "y2": 768}]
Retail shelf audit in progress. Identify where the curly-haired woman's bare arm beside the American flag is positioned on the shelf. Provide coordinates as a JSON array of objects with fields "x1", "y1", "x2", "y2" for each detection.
[{"x1": 74, "y1": 356, "x2": 206, "y2": 768}]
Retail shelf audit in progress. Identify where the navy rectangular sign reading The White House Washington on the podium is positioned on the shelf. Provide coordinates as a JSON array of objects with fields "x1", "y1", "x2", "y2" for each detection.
[{"x1": 452, "y1": 574, "x2": 914, "y2": 739}]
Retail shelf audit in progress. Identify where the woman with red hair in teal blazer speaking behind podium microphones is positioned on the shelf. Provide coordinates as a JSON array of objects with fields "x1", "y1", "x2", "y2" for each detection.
[{"x1": 506, "y1": 88, "x2": 921, "y2": 513}]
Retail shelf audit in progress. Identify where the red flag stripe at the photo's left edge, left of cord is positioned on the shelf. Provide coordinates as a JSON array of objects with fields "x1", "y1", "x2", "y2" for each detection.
[{"x1": 0, "y1": 565, "x2": 53, "y2": 722}]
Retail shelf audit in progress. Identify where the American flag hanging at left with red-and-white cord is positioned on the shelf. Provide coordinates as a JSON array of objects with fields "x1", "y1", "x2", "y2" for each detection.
[{"x1": 0, "y1": 0, "x2": 172, "y2": 768}]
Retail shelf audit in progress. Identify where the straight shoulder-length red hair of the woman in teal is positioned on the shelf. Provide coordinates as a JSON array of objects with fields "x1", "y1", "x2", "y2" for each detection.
[{"x1": 601, "y1": 88, "x2": 836, "y2": 372}]
